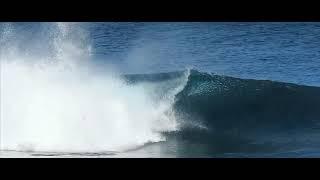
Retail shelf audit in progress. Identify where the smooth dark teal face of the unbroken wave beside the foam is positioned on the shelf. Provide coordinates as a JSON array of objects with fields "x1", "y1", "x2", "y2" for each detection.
[{"x1": 175, "y1": 70, "x2": 320, "y2": 130}]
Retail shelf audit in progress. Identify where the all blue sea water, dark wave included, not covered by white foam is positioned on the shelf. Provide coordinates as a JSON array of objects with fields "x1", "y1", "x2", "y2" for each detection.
[{"x1": 1, "y1": 22, "x2": 320, "y2": 157}]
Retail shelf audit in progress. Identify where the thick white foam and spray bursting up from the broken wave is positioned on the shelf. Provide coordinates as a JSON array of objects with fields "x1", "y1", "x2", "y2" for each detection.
[{"x1": 0, "y1": 23, "x2": 188, "y2": 152}]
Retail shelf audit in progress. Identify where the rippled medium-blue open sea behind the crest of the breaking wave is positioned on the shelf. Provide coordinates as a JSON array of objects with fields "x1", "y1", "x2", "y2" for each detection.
[{"x1": 88, "y1": 22, "x2": 320, "y2": 86}]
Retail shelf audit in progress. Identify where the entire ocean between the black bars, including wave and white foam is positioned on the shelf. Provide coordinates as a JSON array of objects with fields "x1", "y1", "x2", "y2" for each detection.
[{"x1": 0, "y1": 22, "x2": 320, "y2": 158}]
